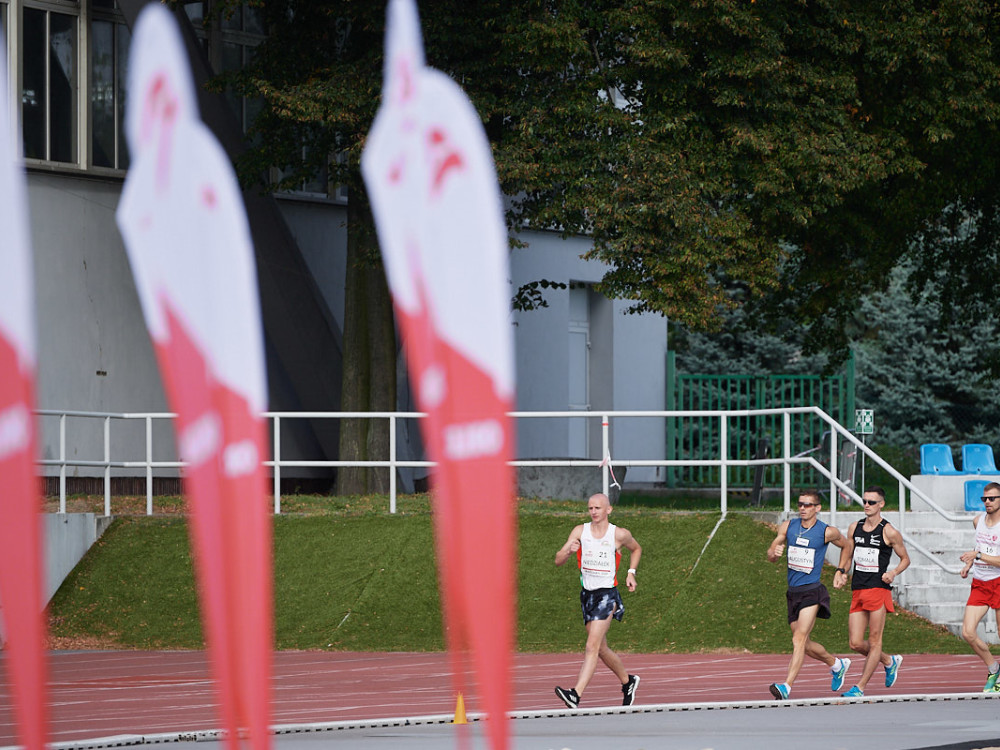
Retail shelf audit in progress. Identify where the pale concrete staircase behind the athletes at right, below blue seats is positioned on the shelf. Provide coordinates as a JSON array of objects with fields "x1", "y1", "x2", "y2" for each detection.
[{"x1": 883, "y1": 511, "x2": 1000, "y2": 644}]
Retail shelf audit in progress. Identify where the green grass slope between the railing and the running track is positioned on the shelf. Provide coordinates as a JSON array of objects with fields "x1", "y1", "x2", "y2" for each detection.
[{"x1": 50, "y1": 502, "x2": 968, "y2": 653}]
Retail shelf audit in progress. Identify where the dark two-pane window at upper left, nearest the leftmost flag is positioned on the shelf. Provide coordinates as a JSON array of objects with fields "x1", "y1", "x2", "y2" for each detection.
[{"x1": 21, "y1": 8, "x2": 79, "y2": 163}]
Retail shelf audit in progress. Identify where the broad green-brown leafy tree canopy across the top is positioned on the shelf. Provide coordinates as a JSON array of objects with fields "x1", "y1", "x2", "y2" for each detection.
[{"x1": 229, "y1": 0, "x2": 1000, "y2": 345}]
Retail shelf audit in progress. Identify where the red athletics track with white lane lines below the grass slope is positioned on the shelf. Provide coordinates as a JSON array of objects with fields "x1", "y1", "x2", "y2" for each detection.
[{"x1": 0, "y1": 651, "x2": 986, "y2": 747}]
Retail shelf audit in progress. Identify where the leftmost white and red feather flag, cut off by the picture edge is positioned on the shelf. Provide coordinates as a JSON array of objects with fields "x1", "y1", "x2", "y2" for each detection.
[{"x1": 0, "y1": 38, "x2": 46, "y2": 750}]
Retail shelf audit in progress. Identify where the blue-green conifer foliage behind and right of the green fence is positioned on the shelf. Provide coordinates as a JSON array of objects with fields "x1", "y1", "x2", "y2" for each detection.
[{"x1": 671, "y1": 258, "x2": 1000, "y2": 455}]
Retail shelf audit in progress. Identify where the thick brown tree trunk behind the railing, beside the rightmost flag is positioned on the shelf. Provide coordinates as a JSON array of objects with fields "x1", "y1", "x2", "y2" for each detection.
[{"x1": 337, "y1": 197, "x2": 396, "y2": 495}]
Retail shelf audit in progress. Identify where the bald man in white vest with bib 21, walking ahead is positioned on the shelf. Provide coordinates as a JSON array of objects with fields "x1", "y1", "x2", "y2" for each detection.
[{"x1": 555, "y1": 493, "x2": 642, "y2": 708}]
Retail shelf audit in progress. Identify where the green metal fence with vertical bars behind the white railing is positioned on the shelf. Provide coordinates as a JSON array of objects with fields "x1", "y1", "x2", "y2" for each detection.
[{"x1": 667, "y1": 352, "x2": 854, "y2": 488}]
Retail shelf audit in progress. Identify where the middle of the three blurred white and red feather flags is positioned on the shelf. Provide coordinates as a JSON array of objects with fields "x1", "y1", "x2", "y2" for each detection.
[{"x1": 117, "y1": 4, "x2": 273, "y2": 750}]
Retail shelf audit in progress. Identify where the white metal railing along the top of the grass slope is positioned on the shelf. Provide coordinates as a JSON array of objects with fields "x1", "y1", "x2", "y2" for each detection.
[{"x1": 37, "y1": 406, "x2": 969, "y2": 573}]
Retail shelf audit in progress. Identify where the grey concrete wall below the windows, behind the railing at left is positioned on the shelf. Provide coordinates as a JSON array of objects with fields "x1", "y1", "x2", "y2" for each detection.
[{"x1": 28, "y1": 172, "x2": 176, "y2": 476}]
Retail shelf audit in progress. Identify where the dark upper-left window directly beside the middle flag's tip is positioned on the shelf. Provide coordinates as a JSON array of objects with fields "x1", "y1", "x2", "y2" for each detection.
[{"x1": 90, "y1": 12, "x2": 131, "y2": 169}]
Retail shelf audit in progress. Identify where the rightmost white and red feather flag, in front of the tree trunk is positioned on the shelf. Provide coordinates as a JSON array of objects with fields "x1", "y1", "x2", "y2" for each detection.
[{"x1": 362, "y1": 0, "x2": 516, "y2": 748}]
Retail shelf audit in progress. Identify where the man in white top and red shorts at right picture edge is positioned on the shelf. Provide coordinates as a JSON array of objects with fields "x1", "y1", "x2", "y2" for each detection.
[{"x1": 962, "y1": 482, "x2": 1000, "y2": 693}]
